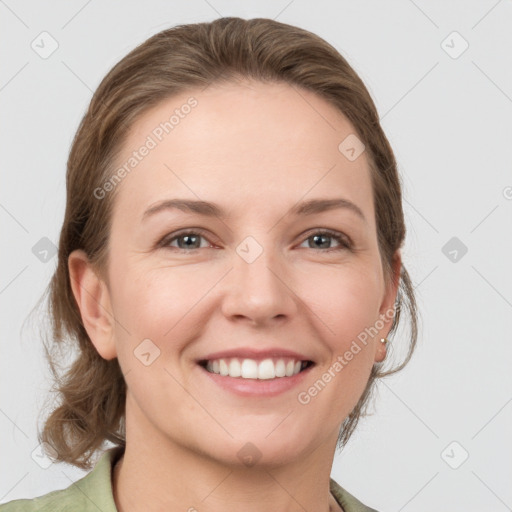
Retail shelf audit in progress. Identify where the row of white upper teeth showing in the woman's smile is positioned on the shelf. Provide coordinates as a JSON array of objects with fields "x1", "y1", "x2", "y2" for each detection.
[{"x1": 206, "y1": 357, "x2": 308, "y2": 379}]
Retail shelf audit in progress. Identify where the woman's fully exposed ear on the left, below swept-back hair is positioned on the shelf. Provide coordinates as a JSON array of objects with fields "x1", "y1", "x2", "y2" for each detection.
[{"x1": 68, "y1": 249, "x2": 117, "y2": 360}]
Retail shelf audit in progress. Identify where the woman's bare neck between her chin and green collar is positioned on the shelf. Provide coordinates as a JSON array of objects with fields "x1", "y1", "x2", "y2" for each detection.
[{"x1": 112, "y1": 394, "x2": 343, "y2": 512}]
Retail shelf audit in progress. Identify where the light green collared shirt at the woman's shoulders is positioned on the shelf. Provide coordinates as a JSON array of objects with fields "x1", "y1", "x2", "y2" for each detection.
[{"x1": 0, "y1": 446, "x2": 377, "y2": 512}]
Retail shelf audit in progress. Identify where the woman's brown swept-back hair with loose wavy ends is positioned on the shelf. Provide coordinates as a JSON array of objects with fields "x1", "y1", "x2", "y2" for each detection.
[{"x1": 38, "y1": 18, "x2": 417, "y2": 469}]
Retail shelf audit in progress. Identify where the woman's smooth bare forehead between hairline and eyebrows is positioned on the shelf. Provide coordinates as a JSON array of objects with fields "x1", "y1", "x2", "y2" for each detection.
[{"x1": 110, "y1": 81, "x2": 373, "y2": 226}]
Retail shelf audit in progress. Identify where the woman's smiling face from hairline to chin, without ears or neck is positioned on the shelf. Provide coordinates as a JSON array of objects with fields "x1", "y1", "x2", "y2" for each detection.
[{"x1": 87, "y1": 82, "x2": 399, "y2": 464}]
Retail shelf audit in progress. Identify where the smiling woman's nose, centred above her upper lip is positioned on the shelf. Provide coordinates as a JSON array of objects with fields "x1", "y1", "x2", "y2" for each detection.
[{"x1": 222, "y1": 240, "x2": 298, "y2": 325}]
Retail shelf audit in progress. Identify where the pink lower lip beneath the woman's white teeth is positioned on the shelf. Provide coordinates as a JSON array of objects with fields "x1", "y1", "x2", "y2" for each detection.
[{"x1": 198, "y1": 362, "x2": 316, "y2": 397}]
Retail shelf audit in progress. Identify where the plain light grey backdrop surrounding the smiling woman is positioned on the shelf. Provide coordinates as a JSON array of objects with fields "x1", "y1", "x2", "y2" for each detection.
[{"x1": 0, "y1": 0, "x2": 512, "y2": 512}]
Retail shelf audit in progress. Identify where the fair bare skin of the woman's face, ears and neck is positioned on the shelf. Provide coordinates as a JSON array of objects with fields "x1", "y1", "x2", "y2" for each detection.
[{"x1": 69, "y1": 82, "x2": 401, "y2": 512}]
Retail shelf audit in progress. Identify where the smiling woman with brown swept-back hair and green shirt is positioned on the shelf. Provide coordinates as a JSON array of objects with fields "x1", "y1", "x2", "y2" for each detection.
[{"x1": 0, "y1": 18, "x2": 417, "y2": 512}]
